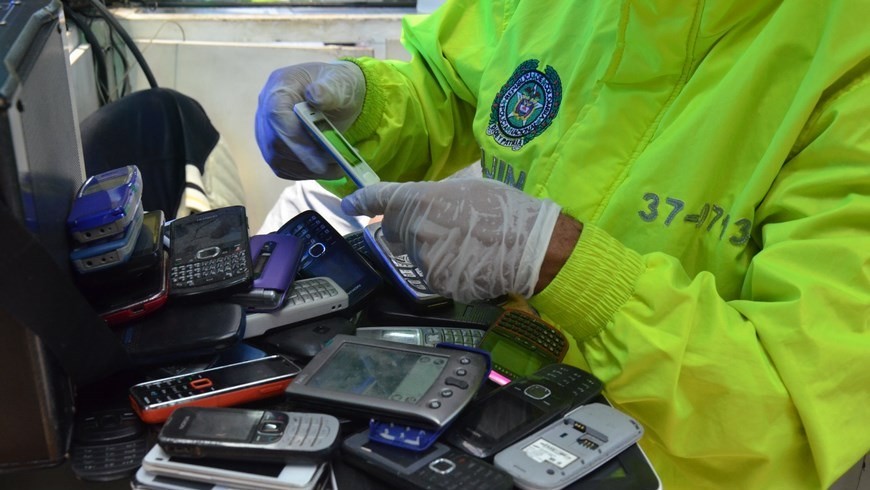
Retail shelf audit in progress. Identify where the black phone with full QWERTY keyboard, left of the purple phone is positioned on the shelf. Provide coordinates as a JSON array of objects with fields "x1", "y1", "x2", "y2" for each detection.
[{"x1": 169, "y1": 206, "x2": 254, "y2": 298}]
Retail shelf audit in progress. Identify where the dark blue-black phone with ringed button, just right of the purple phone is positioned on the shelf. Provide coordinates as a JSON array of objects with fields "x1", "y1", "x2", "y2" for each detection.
[{"x1": 277, "y1": 210, "x2": 383, "y2": 310}]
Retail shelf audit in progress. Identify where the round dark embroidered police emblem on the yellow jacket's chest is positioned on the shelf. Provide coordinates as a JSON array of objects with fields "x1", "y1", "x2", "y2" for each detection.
[{"x1": 486, "y1": 60, "x2": 562, "y2": 151}]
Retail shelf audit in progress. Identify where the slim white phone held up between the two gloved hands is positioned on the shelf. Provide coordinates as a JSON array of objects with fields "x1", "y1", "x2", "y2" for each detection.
[{"x1": 293, "y1": 102, "x2": 381, "y2": 188}]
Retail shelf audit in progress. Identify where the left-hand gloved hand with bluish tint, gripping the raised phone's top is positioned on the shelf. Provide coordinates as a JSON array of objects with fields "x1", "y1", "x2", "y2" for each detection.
[{"x1": 255, "y1": 61, "x2": 366, "y2": 180}]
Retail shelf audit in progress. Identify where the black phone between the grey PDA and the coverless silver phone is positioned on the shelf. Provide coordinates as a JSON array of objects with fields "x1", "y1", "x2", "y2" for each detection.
[{"x1": 445, "y1": 364, "x2": 602, "y2": 458}]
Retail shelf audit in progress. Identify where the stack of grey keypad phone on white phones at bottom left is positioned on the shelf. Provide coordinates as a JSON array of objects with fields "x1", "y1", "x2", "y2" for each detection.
[{"x1": 134, "y1": 407, "x2": 340, "y2": 490}]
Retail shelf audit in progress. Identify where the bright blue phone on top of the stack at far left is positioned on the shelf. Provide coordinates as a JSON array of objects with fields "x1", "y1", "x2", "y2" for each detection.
[{"x1": 66, "y1": 165, "x2": 142, "y2": 244}]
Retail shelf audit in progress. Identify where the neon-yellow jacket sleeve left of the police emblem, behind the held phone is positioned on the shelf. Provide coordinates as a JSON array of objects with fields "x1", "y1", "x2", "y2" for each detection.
[{"x1": 323, "y1": 0, "x2": 503, "y2": 195}]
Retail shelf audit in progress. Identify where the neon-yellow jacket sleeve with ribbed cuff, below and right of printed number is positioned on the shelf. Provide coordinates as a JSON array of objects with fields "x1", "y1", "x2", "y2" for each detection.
[{"x1": 532, "y1": 71, "x2": 870, "y2": 488}]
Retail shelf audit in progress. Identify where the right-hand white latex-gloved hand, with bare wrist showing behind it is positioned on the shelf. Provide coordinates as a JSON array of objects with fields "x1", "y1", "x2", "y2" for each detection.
[{"x1": 341, "y1": 178, "x2": 561, "y2": 303}]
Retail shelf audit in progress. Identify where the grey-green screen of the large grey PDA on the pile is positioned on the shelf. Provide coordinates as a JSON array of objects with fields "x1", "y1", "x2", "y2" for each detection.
[{"x1": 308, "y1": 344, "x2": 448, "y2": 404}]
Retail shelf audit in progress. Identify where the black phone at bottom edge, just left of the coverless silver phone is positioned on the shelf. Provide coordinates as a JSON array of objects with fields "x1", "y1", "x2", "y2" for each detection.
[{"x1": 341, "y1": 430, "x2": 513, "y2": 490}]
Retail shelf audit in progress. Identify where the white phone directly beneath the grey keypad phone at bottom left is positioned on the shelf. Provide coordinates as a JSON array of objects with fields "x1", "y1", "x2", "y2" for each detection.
[{"x1": 142, "y1": 444, "x2": 327, "y2": 490}]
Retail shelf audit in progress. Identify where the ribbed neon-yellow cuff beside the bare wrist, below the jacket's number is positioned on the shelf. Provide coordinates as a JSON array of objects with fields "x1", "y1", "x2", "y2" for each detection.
[{"x1": 530, "y1": 223, "x2": 644, "y2": 342}]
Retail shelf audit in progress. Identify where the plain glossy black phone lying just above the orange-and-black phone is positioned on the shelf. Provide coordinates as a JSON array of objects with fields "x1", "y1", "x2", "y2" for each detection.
[{"x1": 116, "y1": 302, "x2": 245, "y2": 365}]
